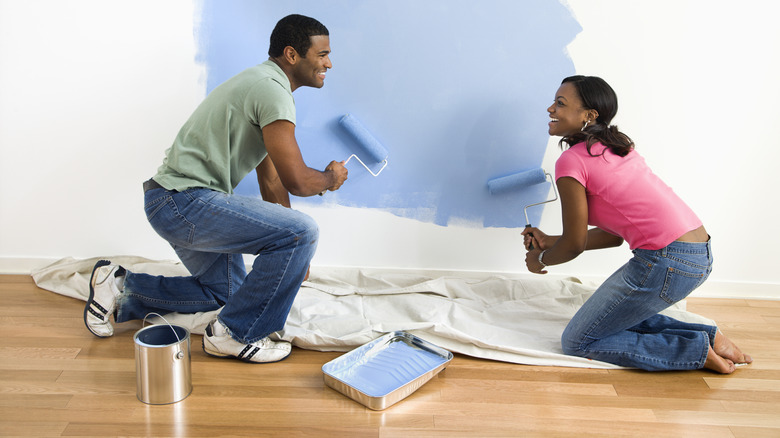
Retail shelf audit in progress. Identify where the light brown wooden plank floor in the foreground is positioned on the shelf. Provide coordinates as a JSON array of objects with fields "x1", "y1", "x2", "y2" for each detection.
[{"x1": 0, "y1": 275, "x2": 780, "y2": 438}]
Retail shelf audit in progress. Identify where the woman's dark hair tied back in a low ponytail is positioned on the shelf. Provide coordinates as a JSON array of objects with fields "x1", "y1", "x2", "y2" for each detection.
[{"x1": 558, "y1": 75, "x2": 634, "y2": 157}]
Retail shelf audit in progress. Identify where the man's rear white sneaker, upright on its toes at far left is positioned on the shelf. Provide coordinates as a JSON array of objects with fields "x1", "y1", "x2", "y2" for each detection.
[{"x1": 84, "y1": 260, "x2": 126, "y2": 338}]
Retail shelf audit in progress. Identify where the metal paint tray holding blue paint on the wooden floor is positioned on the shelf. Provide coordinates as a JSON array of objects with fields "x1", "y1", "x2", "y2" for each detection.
[{"x1": 322, "y1": 331, "x2": 453, "y2": 410}]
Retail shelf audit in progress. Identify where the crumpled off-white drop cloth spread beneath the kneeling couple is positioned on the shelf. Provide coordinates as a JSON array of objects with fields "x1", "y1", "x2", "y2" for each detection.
[{"x1": 33, "y1": 256, "x2": 714, "y2": 368}]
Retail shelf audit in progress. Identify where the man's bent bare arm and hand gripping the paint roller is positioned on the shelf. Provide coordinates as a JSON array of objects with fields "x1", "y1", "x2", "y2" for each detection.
[{"x1": 258, "y1": 120, "x2": 347, "y2": 197}]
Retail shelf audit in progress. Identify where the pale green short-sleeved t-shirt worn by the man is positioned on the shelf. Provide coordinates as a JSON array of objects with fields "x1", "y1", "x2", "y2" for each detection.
[{"x1": 154, "y1": 60, "x2": 295, "y2": 193}]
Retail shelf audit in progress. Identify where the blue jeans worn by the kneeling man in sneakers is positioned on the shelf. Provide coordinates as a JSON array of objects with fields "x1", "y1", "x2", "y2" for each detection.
[{"x1": 116, "y1": 188, "x2": 319, "y2": 343}]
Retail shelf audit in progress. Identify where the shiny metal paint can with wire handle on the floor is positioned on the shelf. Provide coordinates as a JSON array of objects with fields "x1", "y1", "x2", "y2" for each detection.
[{"x1": 133, "y1": 324, "x2": 192, "y2": 405}]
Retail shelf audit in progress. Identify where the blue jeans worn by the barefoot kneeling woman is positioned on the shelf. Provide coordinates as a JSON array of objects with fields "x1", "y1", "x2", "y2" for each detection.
[{"x1": 561, "y1": 238, "x2": 717, "y2": 371}]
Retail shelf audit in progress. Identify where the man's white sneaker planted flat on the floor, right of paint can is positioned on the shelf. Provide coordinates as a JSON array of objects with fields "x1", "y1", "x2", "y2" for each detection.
[{"x1": 203, "y1": 319, "x2": 292, "y2": 363}]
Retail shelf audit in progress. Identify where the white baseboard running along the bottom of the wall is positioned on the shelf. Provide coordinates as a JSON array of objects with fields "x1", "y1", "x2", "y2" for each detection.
[{"x1": 0, "y1": 257, "x2": 780, "y2": 300}]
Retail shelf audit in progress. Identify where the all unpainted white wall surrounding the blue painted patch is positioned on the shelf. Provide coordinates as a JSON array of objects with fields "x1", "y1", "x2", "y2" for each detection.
[{"x1": 0, "y1": 0, "x2": 780, "y2": 297}]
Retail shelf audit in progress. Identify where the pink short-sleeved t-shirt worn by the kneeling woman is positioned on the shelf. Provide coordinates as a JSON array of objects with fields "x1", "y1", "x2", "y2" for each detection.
[{"x1": 555, "y1": 143, "x2": 702, "y2": 249}]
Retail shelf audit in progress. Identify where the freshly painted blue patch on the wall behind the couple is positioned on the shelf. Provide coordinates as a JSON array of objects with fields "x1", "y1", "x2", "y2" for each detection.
[{"x1": 196, "y1": 0, "x2": 581, "y2": 227}]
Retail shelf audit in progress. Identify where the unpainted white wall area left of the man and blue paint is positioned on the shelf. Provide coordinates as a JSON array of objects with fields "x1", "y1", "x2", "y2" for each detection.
[{"x1": 0, "y1": 0, "x2": 205, "y2": 271}]
